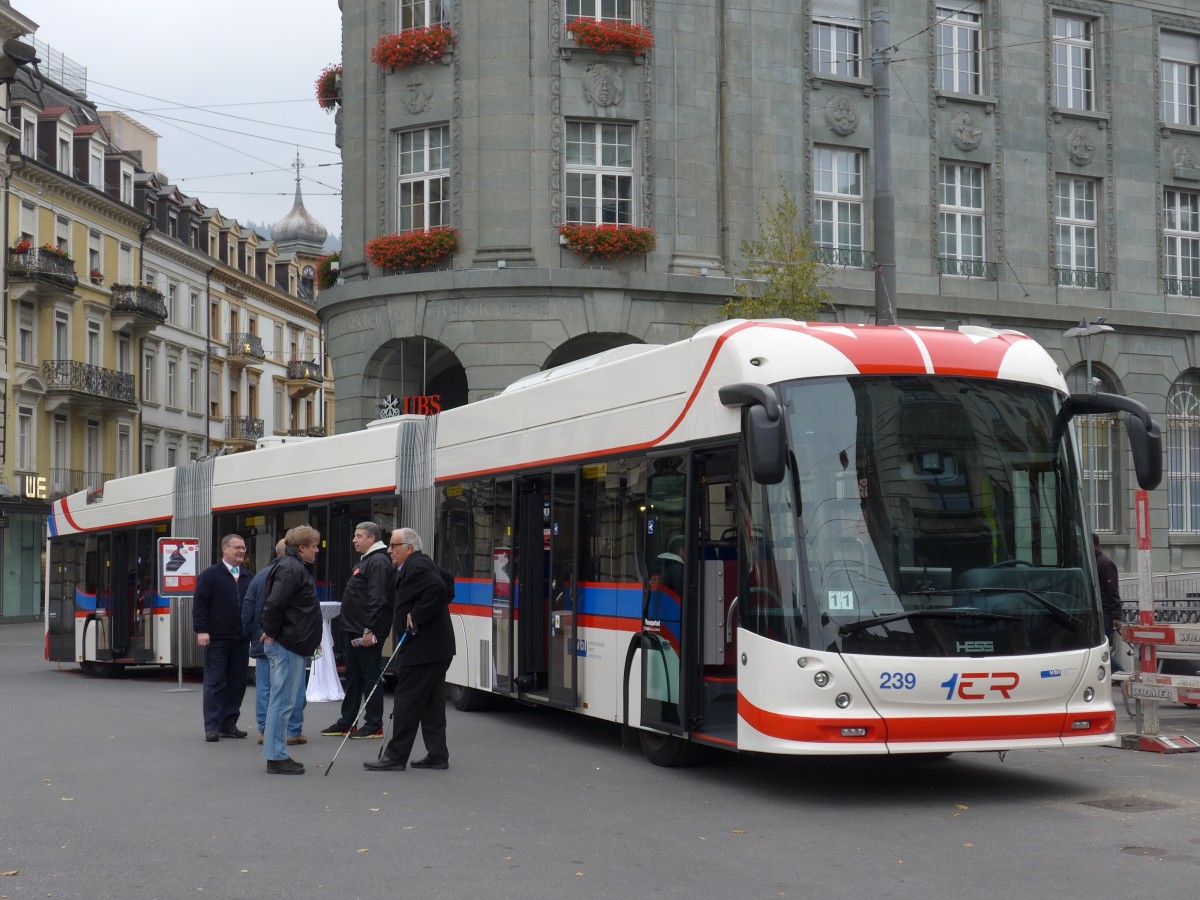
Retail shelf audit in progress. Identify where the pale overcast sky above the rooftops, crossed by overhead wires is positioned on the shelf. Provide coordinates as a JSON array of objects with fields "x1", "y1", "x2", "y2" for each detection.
[{"x1": 32, "y1": 0, "x2": 342, "y2": 240}]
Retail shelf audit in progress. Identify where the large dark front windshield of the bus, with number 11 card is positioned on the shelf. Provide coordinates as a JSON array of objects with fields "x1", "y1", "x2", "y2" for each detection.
[{"x1": 744, "y1": 376, "x2": 1103, "y2": 656}]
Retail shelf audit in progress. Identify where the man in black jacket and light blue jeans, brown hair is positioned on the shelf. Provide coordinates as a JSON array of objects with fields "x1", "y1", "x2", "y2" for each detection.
[{"x1": 259, "y1": 526, "x2": 320, "y2": 775}]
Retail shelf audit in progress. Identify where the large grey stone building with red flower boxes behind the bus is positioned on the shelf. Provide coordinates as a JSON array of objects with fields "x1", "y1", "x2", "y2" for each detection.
[{"x1": 318, "y1": 0, "x2": 1200, "y2": 571}]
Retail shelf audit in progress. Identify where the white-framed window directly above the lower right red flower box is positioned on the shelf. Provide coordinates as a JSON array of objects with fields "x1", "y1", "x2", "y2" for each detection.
[{"x1": 563, "y1": 119, "x2": 638, "y2": 226}]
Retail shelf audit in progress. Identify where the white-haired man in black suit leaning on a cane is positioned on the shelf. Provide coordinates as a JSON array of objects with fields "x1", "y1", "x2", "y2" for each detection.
[{"x1": 362, "y1": 528, "x2": 455, "y2": 772}]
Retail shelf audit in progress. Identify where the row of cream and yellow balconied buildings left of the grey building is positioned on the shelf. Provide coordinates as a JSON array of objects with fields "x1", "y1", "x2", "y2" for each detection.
[{"x1": 0, "y1": 31, "x2": 332, "y2": 620}]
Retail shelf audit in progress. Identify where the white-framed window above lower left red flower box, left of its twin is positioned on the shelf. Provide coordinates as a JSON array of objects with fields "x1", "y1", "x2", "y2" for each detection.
[{"x1": 396, "y1": 125, "x2": 450, "y2": 232}]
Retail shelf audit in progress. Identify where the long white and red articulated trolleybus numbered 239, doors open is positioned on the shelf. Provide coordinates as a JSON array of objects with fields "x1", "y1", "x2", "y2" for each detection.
[{"x1": 47, "y1": 320, "x2": 1162, "y2": 764}]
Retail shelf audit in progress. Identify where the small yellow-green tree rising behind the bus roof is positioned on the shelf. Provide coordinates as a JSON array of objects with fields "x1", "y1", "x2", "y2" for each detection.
[{"x1": 721, "y1": 184, "x2": 833, "y2": 322}]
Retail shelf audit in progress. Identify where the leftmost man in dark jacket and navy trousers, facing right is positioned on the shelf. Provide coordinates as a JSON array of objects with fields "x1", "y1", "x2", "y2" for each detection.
[{"x1": 192, "y1": 534, "x2": 250, "y2": 740}]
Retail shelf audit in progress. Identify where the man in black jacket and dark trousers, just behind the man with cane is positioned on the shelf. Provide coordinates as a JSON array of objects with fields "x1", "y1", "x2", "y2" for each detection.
[{"x1": 320, "y1": 522, "x2": 396, "y2": 739}]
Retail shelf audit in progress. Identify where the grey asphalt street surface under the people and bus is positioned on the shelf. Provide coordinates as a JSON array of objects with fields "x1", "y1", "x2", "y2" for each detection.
[{"x1": 0, "y1": 624, "x2": 1200, "y2": 900}]
